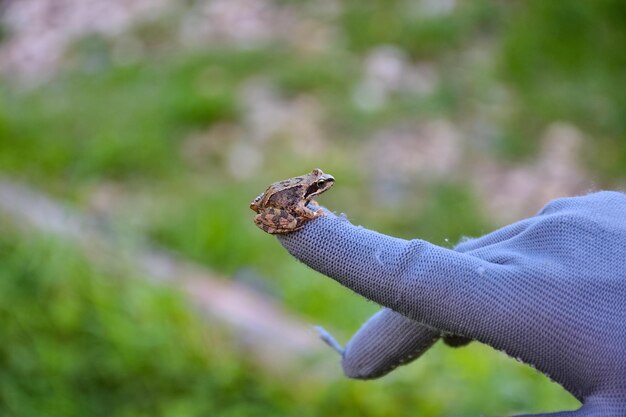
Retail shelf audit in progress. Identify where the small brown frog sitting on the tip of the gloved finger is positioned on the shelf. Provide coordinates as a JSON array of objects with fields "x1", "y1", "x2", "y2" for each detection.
[{"x1": 250, "y1": 168, "x2": 335, "y2": 234}]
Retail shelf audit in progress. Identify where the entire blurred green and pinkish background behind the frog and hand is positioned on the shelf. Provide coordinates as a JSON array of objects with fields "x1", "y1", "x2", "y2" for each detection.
[{"x1": 0, "y1": 0, "x2": 626, "y2": 417}]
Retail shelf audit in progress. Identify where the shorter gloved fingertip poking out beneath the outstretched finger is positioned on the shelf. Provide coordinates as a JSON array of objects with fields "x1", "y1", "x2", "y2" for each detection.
[{"x1": 341, "y1": 309, "x2": 439, "y2": 379}]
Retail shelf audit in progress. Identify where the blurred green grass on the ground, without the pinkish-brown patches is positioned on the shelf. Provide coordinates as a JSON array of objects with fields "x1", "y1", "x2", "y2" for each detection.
[{"x1": 0, "y1": 0, "x2": 626, "y2": 416}]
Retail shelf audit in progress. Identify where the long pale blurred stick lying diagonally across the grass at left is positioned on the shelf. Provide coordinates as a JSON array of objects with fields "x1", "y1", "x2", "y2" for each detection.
[{"x1": 0, "y1": 179, "x2": 330, "y2": 372}]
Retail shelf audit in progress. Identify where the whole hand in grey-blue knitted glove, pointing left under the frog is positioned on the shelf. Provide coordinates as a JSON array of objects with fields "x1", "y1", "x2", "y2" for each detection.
[{"x1": 279, "y1": 192, "x2": 626, "y2": 417}]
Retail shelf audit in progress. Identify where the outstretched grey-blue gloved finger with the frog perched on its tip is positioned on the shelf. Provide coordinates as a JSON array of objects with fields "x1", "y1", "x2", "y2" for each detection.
[{"x1": 279, "y1": 214, "x2": 517, "y2": 346}]
